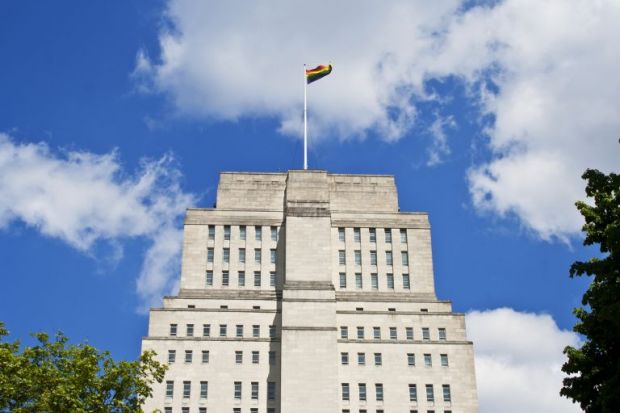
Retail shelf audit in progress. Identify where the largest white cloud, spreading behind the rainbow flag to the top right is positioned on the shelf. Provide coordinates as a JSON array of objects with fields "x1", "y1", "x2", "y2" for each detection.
[{"x1": 140, "y1": 0, "x2": 620, "y2": 239}]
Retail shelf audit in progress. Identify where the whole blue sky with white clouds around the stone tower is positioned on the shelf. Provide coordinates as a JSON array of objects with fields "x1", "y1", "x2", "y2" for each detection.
[{"x1": 0, "y1": 0, "x2": 620, "y2": 412}]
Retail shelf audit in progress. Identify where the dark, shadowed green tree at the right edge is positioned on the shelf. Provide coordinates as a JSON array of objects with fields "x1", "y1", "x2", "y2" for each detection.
[{"x1": 560, "y1": 169, "x2": 620, "y2": 413}]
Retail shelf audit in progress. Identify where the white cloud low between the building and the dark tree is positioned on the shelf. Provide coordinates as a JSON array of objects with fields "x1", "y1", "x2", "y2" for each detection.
[{"x1": 466, "y1": 308, "x2": 581, "y2": 413}]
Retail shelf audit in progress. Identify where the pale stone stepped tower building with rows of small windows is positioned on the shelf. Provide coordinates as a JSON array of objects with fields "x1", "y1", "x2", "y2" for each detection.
[{"x1": 142, "y1": 170, "x2": 478, "y2": 413}]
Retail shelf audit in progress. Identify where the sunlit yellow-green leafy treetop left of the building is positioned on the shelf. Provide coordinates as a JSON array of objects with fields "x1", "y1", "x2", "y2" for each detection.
[{"x1": 0, "y1": 322, "x2": 167, "y2": 413}]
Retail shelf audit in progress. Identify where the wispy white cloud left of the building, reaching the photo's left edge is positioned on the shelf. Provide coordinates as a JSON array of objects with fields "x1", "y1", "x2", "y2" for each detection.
[{"x1": 0, "y1": 133, "x2": 195, "y2": 307}]
